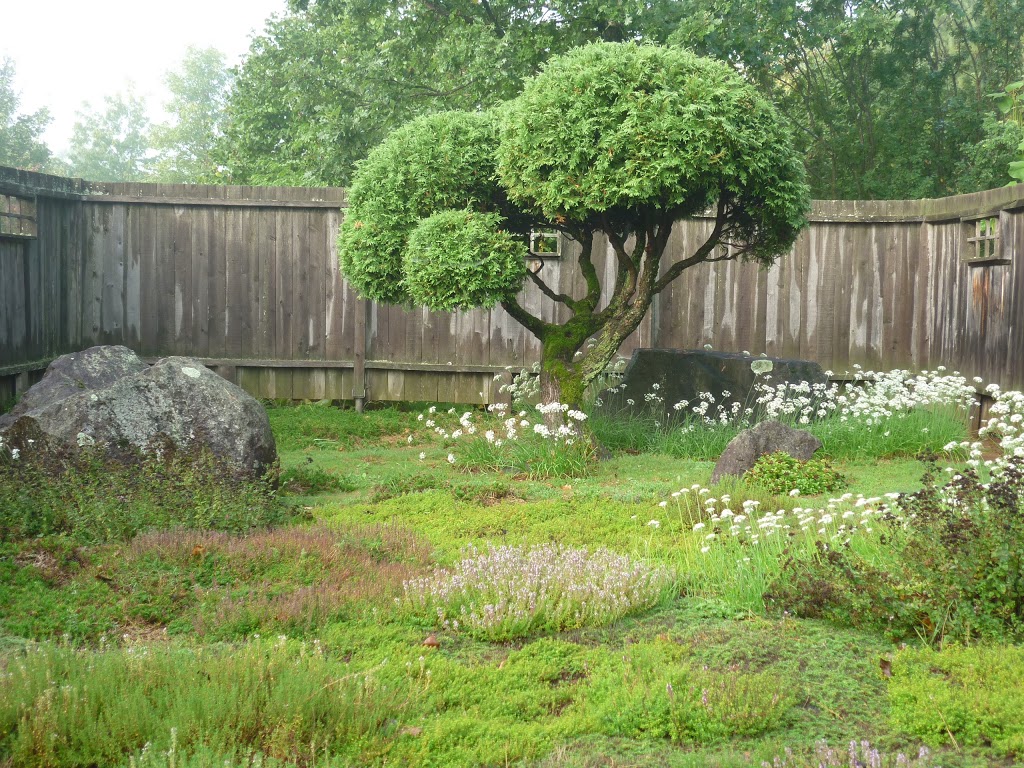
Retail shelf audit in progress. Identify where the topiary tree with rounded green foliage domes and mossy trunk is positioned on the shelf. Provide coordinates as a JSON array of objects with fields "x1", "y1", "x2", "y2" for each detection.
[{"x1": 339, "y1": 43, "x2": 809, "y2": 415}]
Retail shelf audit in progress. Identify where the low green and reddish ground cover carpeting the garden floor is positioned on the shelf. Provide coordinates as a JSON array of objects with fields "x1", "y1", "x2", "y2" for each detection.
[{"x1": 0, "y1": 397, "x2": 1016, "y2": 768}]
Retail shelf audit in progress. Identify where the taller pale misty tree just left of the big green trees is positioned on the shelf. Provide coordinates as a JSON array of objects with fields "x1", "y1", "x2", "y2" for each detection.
[{"x1": 151, "y1": 46, "x2": 231, "y2": 183}]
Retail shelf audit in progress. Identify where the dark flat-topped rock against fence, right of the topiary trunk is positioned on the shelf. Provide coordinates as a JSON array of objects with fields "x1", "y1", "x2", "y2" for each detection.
[{"x1": 600, "y1": 349, "x2": 828, "y2": 415}]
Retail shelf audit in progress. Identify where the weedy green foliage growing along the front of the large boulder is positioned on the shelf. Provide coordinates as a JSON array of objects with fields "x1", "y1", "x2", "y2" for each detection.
[{"x1": 0, "y1": 447, "x2": 285, "y2": 543}]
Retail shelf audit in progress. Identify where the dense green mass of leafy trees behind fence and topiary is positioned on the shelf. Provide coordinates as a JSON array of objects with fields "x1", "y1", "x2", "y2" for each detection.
[{"x1": 221, "y1": 0, "x2": 1024, "y2": 199}]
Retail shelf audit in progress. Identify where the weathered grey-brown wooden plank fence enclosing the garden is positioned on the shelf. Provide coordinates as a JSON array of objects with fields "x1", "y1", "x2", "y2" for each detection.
[{"x1": 0, "y1": 169, "x2": 1024, "y2": 402}]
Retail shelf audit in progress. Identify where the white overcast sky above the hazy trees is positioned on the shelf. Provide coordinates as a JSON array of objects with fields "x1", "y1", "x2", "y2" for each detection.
[{"x1": 0, "y1": 0, "x2": 286, "y2": 155}]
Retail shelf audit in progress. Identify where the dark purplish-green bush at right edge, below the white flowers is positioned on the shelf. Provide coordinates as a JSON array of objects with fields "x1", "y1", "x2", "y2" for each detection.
[{"x1": 765, "y1": 461, "x2": 1024, "y2": 641}]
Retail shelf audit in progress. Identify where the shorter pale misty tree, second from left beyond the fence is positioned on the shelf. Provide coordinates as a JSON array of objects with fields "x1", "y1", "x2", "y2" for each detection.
[{"x1": 68, "y1": 87, "x2": 152, "y2": 181}]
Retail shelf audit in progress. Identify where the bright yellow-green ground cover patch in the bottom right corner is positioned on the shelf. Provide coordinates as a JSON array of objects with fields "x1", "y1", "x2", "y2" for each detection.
[{"x1": 889, "y1": 646, "x2": 1024, "y2": 758}]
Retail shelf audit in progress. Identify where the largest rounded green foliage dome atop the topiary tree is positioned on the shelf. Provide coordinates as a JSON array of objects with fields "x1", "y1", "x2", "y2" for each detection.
[{"x1": 498, "y1": 43, "x2": 808, "y2": 263}]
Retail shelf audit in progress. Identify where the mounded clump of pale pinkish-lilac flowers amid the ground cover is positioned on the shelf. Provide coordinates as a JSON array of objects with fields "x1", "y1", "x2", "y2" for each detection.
[{"x1": 404, "y1": 544, "x2": 674, "y2": 641}]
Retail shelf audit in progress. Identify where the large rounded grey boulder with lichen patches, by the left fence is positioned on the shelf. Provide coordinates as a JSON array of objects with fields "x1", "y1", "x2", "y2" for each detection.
[{"x1": 0, "y1": 346, "x2": 278, "y2": 477}]
